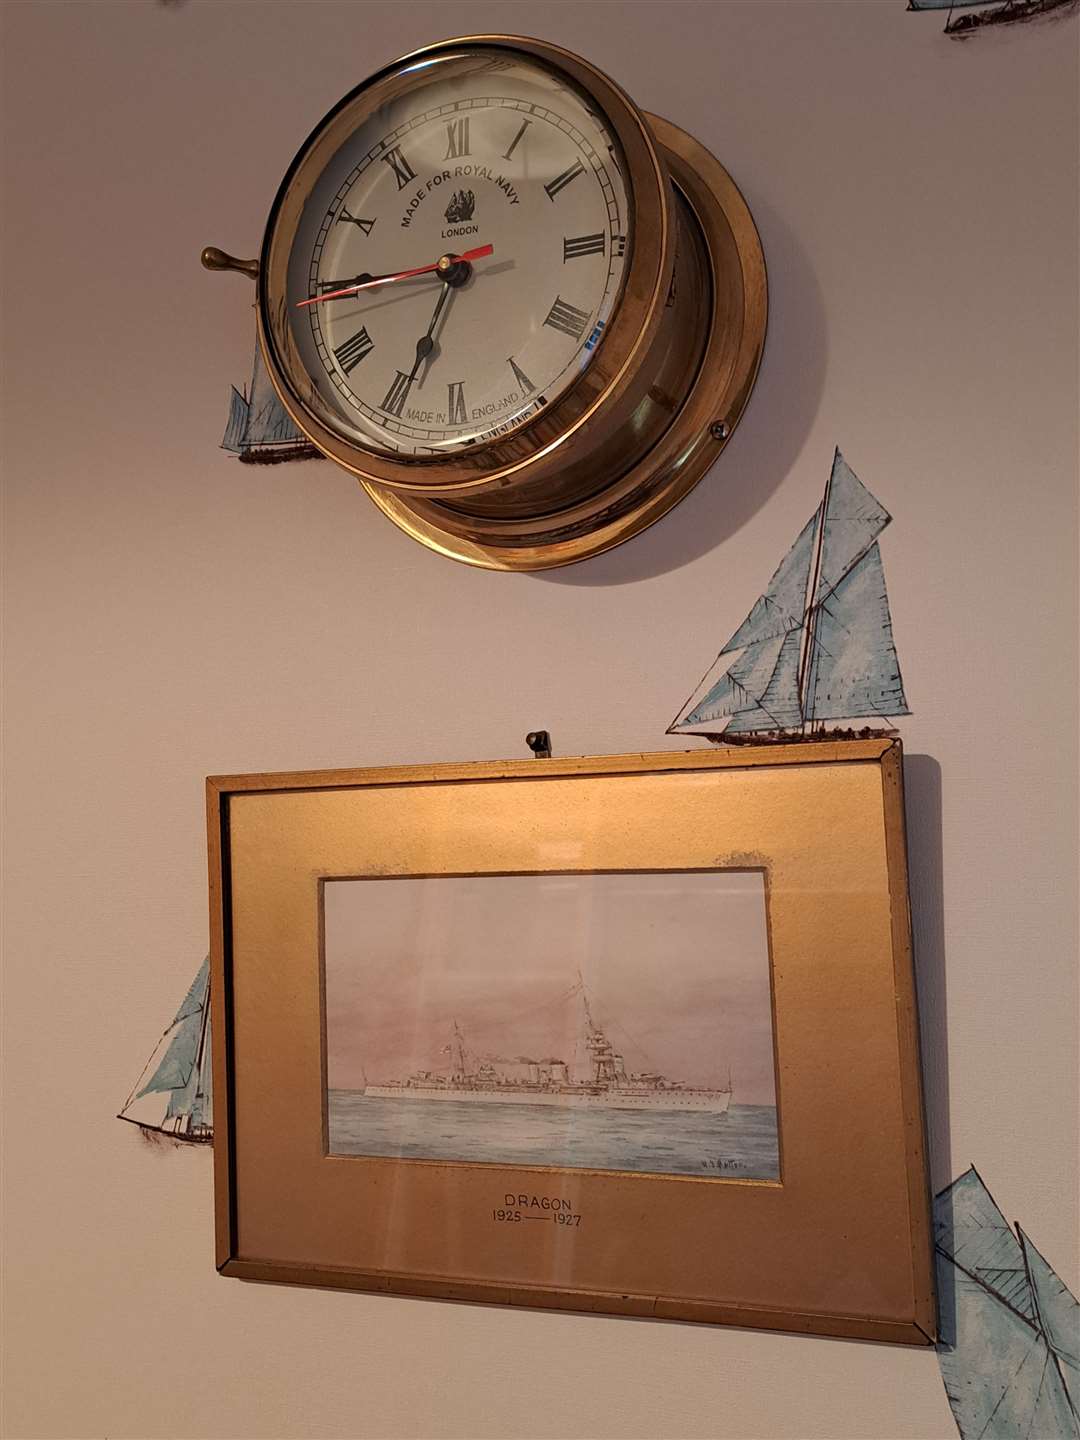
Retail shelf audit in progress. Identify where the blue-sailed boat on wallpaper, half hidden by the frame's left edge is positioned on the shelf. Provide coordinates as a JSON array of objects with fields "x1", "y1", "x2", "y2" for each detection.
[{"x1": 118, "y1": 959, "x2": 213, "y2": 1142}]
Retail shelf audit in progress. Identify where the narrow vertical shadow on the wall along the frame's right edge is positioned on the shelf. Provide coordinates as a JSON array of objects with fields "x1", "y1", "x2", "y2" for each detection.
[{"x1": 904, "y1": 755, "x2": 952, "y2": 1192}]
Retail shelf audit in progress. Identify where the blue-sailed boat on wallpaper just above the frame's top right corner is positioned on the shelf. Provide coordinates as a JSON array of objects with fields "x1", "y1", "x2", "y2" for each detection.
[{"x1": 668, "y1": 451, "x2": 910, "y2": 743}]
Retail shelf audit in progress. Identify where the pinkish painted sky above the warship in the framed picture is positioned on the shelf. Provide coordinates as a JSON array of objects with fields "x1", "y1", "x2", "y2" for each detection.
[{"x1": 325, "y1": 871, "x2": 775, "y2": 1104}]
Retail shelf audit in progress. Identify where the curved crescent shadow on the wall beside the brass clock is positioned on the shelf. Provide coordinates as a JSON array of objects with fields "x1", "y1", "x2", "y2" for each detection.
[{"x1": 533, "y1": 200, "x2": 825, "y2": 585}]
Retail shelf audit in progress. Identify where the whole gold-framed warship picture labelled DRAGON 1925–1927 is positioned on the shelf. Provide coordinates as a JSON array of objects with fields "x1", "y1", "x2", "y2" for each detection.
[{"x1": 207, "y1": 739, "x2": 936, "y2": 1345}]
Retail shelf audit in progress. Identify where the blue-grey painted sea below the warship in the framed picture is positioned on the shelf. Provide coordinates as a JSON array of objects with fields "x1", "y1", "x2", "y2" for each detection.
[{"x1": 328, "y1": 1090, "x2": 780, "y2": 1179}]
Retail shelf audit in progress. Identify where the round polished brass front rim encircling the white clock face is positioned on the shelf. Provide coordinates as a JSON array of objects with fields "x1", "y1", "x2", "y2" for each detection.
[{"x1": 258, "y1": 35, "x2": 674, "y2": 497}]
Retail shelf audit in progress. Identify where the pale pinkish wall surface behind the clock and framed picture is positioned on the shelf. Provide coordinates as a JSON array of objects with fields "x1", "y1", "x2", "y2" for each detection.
[{"x1": 1, "y1": 0, "x2": 1080, "y2": 1440}]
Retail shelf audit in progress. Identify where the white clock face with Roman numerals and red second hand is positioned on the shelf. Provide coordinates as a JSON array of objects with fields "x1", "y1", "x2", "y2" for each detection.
[{"x1": 288, "y1": 50, "x2": 629, "y2": 459}]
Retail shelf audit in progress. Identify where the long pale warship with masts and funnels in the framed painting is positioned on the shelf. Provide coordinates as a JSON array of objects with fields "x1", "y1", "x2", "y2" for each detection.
[{"x1": 361, "y1": 984, "x2": 732, "y2": 1115}]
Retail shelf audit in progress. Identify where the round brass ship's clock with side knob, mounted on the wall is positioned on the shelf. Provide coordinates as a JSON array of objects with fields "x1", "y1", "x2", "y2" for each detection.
[{"x1": 203, "y1": 36, "x2": 768, "y2": 570}]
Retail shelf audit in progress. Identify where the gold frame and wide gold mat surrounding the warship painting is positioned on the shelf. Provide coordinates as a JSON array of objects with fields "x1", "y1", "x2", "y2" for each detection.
[{"x1": 207, "y1": 739, "x2": 936, "y2": 1345}]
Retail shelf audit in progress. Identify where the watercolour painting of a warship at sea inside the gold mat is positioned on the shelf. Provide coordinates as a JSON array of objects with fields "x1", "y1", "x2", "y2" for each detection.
[{"x1": 324, "y1": 871, "x2": 779, "y2": 1179}]
